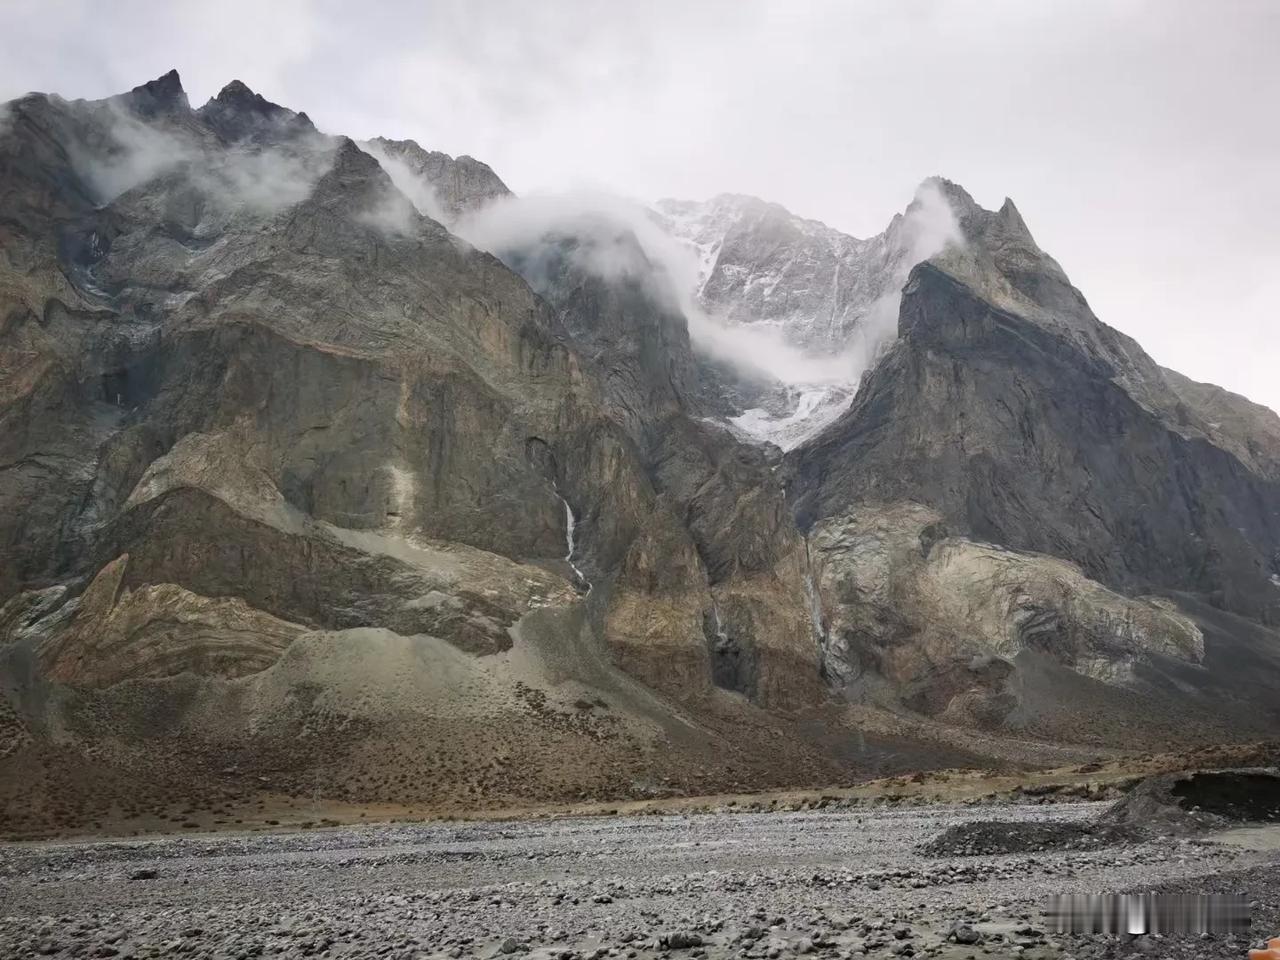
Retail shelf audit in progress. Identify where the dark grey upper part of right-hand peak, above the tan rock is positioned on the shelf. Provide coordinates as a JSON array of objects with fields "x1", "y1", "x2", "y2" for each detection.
[{"x1": 794, "y1": 187, "x2": 1280, "y2": 623}]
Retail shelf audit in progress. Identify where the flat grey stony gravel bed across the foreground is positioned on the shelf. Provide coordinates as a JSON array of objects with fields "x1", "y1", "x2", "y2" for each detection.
[{"x1": 0, "y1": 804, "x2": 1280, "y2": 960}]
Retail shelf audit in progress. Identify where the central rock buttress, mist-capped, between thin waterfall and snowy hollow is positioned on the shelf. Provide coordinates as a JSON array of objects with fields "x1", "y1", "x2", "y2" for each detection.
[{"x1": 483, "y1": 208, "x2": 820, "y2": 707}]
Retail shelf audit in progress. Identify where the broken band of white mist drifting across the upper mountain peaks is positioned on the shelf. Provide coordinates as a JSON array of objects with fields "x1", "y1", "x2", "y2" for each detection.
[{"x1": 57, "y1": 87, "x2": 963, "y2": 443}]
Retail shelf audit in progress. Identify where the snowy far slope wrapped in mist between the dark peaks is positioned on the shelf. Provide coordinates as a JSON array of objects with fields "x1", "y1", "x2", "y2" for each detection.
[{"x1": 657, "y1": 180, "x2": 960, "y2": 449}]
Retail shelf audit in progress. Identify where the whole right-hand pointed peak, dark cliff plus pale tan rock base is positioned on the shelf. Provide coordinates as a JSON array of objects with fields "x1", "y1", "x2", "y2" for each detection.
[{"x1": 787, "y1": 184, "x2": 1280, "y2": 737}]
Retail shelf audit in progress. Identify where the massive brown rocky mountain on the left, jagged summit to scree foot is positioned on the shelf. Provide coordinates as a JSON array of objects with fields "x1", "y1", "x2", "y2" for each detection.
[{"x1": 0, "y1": 76, "x2": 836, "y2": 834}]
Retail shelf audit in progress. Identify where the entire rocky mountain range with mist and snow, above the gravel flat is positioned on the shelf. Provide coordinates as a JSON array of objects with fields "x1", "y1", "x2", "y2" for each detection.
[{"x1": 0, "y1": 73, "x2": 1280, "y2": 835}]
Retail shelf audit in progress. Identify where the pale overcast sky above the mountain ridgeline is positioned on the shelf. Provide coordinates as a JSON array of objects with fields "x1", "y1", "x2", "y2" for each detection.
[{"x1": 0, "y1": 0, "x2": 1280, "y2": 410}]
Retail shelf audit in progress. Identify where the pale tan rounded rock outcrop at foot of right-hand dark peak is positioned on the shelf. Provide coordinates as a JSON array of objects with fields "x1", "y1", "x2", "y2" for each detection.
[{"x1": 809, "y1": 502, "x2": 1268, "y2": 741}]
